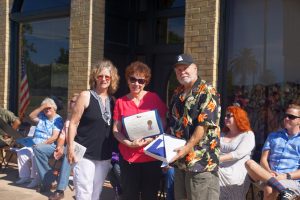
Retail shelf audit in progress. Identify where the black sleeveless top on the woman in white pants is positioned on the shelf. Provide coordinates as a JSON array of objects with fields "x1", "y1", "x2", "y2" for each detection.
[{"x1": 75, "y1": 93, "x2": 114, "y2": 160}]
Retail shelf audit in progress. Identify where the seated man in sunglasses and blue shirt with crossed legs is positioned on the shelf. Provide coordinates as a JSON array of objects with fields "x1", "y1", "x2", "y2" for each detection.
[{"x1": 246, "y1": 103, "x2": 300, "y2": 199}]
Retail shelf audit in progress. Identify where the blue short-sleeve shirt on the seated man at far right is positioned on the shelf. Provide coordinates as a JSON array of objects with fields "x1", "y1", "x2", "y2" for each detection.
[{"x1": 263, "y1": 129, "x2": 300, "y2": 177}]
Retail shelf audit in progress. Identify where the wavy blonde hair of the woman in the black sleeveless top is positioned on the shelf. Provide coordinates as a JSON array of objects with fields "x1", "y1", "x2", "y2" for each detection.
[{"x1": 89, "y1": 60, "x2": 120, "y2": 95}]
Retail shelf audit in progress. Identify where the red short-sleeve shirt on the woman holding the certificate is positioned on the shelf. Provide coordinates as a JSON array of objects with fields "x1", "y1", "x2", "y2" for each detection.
[{"x1": 113, "y1": 92, "x2": 167, "y2": 162}]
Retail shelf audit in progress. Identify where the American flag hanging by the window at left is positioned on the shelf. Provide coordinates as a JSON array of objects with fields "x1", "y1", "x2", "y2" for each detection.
[{"x1": 19, "y1": 52, "x2": 29, "y2": 118}]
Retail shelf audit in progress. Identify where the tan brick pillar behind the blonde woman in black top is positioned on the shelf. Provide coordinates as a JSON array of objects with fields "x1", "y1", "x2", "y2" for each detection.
[{"x1": 68, "y1": 0, "x2": 105, "y2": 98}]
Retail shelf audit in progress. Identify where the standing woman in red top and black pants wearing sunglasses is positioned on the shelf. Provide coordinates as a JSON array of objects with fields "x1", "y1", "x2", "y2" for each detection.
[{"x1": 113, "y1": 61, "x2": 167, "y2": 200}]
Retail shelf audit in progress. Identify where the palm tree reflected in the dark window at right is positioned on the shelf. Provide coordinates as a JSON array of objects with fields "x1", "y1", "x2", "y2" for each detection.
[{"x1": 229, "y1": 48, "x2": 258, "y2": 85}]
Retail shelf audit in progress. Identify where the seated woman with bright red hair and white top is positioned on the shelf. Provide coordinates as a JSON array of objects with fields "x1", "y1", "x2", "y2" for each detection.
[{"x1": 219, "y1": 106, "x2": 255, "y2": 200}]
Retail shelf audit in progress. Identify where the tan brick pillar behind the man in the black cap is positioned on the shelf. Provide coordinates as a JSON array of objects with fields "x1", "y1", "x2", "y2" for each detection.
[{"x1": 184, "y1": 0, "x2": 220, "y2": 86}]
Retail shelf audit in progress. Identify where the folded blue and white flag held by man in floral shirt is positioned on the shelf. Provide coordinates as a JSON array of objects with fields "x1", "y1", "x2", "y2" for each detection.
[{"x1": 144, "y1": 134, "x2": 186, "y2": 163}]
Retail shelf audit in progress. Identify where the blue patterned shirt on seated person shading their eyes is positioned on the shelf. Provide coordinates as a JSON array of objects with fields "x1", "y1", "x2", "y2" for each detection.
[{"x1": 33, "y1": 112, "x2": 63, "y2": 144}]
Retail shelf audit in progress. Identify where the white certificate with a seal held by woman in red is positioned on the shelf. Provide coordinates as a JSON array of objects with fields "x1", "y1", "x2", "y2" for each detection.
[{"x1": 122, "y1": 110, "x2": 163, "y2": 140}]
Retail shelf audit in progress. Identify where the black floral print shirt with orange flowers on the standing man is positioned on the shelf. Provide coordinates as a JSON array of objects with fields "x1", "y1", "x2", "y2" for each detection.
[{"x1": 169, "y1": 78, "x2": 221, "y2": 172}]
